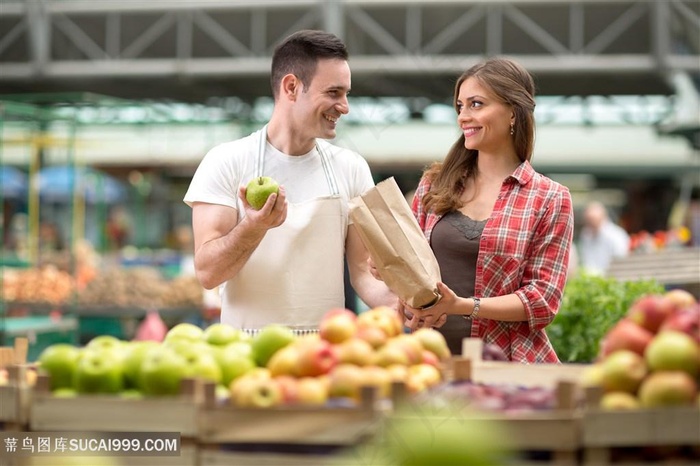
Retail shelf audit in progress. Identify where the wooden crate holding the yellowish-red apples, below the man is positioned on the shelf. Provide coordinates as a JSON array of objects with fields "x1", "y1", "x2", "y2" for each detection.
[{"x1": 198, "y1": 384, "x2": 383, "y2": 466}]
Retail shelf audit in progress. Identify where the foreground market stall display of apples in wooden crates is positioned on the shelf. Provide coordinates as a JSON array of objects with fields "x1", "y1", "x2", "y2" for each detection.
[{"x1": 0, "y1": 291, "x2": 700, "y2": 466}]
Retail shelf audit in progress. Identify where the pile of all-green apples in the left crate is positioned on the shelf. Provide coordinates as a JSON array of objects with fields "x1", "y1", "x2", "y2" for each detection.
[{"x1": 37, "y1": 323, "x2": 256, "y2": 398}]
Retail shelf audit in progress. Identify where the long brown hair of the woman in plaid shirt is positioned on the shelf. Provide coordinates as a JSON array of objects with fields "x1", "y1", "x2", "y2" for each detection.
[{"x1": 423, "y1": 58, "x2": 535, "y2": 215}]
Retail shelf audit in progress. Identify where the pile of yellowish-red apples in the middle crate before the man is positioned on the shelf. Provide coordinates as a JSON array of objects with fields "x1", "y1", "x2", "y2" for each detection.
[{"x1": 230, "y1": 307, "x2": 450, "y2": 408}]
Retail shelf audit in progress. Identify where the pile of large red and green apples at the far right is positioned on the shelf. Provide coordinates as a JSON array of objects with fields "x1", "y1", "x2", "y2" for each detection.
[{"x1": 583, "y1": 289, "x2": 700, "y2": 410}]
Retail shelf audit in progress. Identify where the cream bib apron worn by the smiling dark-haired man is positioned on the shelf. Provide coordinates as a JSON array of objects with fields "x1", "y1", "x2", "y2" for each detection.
[{"x1": 221, "y1": 126, "x2": 347, "y2": 333}]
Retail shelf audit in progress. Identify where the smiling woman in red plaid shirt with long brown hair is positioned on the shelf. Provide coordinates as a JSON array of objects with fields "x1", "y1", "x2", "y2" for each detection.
[{"x1": 404, "y1": 58, "x2": 574, "y2": 363}]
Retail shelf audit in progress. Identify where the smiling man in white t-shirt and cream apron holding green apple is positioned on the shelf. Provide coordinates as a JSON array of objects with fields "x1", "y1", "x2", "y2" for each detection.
[{"x1": 184, "y1": 30, "x2": 397, "y2": 331}]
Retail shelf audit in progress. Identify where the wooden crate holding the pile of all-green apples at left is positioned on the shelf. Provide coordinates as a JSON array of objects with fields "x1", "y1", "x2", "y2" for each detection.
[{"x1": 29, "y1": 375, "x2": 200, "y2": 438}]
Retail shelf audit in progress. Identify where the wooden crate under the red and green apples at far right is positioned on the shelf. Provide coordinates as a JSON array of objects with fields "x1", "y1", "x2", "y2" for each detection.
[{"x1": 582, "y1": 388, "x2": 700, "y2": 465}]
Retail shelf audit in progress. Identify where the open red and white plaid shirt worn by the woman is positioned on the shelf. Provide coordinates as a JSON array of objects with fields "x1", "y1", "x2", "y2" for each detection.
[{"x1": 412, "y1": 162, "x2": 574, "y2": 363}]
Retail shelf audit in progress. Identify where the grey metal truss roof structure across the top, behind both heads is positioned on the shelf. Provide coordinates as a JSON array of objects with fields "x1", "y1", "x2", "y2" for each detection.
[{"x1": 0, "y1": 0, "x2": 700, "y2": 105}]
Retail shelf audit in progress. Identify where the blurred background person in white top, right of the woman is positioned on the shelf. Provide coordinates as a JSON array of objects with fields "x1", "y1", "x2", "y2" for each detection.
[{"x1": 579, "y1": 201, "x2": 630, "y2": 275}]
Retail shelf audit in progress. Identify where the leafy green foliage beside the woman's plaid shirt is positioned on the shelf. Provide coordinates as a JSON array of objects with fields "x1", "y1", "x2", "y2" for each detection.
[{"x1": 547, "y1": 272, "x2": 665, "y2": 363}]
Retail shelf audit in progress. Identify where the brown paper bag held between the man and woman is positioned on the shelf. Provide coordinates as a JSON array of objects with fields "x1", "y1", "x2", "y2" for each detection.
[{"x1": 350, "y1": 177, "x2": 440, "y2": 308}]
